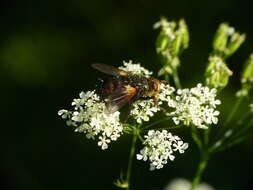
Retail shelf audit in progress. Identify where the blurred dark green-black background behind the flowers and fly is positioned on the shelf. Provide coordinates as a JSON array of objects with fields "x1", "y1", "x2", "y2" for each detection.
[{"x1": 0, "y1": 0, "x2": 253, "y2": 190}]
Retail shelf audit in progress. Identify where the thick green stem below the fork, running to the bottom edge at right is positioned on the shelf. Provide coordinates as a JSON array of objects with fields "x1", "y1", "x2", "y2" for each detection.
[{"x1": 191, "y1": 155, "x2": 208, "y2": 190}]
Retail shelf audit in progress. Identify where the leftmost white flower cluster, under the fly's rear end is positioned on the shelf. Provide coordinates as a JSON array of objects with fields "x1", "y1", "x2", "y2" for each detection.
[{"x1": 58, "y1": 91, "x2": 123, "y2": 150}]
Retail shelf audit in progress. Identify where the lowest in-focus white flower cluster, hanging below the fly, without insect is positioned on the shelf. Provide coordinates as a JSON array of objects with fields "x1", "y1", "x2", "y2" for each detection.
[{"x1": 136, "y1": 130, "x2": 188, "y2": 170}]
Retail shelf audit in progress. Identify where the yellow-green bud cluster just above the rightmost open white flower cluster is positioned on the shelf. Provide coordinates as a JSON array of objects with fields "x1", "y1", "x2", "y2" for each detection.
[{"x1": 205, "y1": 56, "x2": 233, "y2": 89}]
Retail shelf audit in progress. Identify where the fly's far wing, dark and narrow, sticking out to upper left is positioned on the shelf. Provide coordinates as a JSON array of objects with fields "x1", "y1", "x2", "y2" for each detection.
[{"x1": 91, "y1": 63, "x2": 128, "y2": 76}]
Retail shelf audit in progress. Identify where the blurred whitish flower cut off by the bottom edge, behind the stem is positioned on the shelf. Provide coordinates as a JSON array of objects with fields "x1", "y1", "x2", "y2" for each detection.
[{"x1": 164, "y1": 178, "x2": 214, "y2": 190}]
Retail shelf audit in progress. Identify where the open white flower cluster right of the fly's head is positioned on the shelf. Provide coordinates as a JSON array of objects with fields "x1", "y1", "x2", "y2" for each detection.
[{"x1": 170, "y1": 84, "x2": 221, "y2": 128}]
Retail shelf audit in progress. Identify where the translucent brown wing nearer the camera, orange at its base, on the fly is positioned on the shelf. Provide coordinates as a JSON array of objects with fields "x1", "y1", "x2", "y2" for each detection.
[{"x1": 106, "y1": 85, "x2": 136, "y2": 113}]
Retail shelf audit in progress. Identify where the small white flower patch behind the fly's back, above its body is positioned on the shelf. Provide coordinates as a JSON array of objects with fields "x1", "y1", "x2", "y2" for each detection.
[{"x1": 119, "y1": 60, "x2": 152, "y2": 77}]
